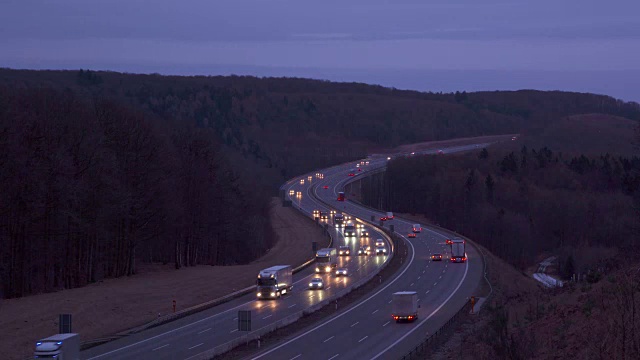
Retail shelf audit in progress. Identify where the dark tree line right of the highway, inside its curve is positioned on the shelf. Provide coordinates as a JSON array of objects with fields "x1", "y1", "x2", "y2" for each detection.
[{"x1": 362, "y1": 147, "x2": 640, "y2": 275}]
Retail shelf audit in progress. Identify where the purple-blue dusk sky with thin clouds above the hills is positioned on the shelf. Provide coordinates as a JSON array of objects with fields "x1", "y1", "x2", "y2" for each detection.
[{"x1": 0, "y1": 0, "x2": 640, "y2": 101}]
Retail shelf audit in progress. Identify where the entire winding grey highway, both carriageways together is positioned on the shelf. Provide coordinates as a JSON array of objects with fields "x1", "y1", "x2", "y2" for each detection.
[{"x1": 81, "y1": 144, "x2": 484, "y2": 359}]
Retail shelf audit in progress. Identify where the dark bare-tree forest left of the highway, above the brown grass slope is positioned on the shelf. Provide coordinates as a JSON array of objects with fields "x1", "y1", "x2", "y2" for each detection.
[{"x1": 0, "y1": 88, "x2": 274, "y2": 298}]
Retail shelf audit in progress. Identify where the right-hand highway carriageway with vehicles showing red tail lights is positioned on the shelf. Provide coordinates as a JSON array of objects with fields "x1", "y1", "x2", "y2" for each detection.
[{"x1": 249, "y1": 144, "x2": 487, "y2": 360}]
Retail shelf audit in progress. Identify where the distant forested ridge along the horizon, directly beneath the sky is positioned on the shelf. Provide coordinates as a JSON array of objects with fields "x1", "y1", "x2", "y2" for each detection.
[{"x1": 0, "y1": 69, "x2": 640, "y2": 187}]
